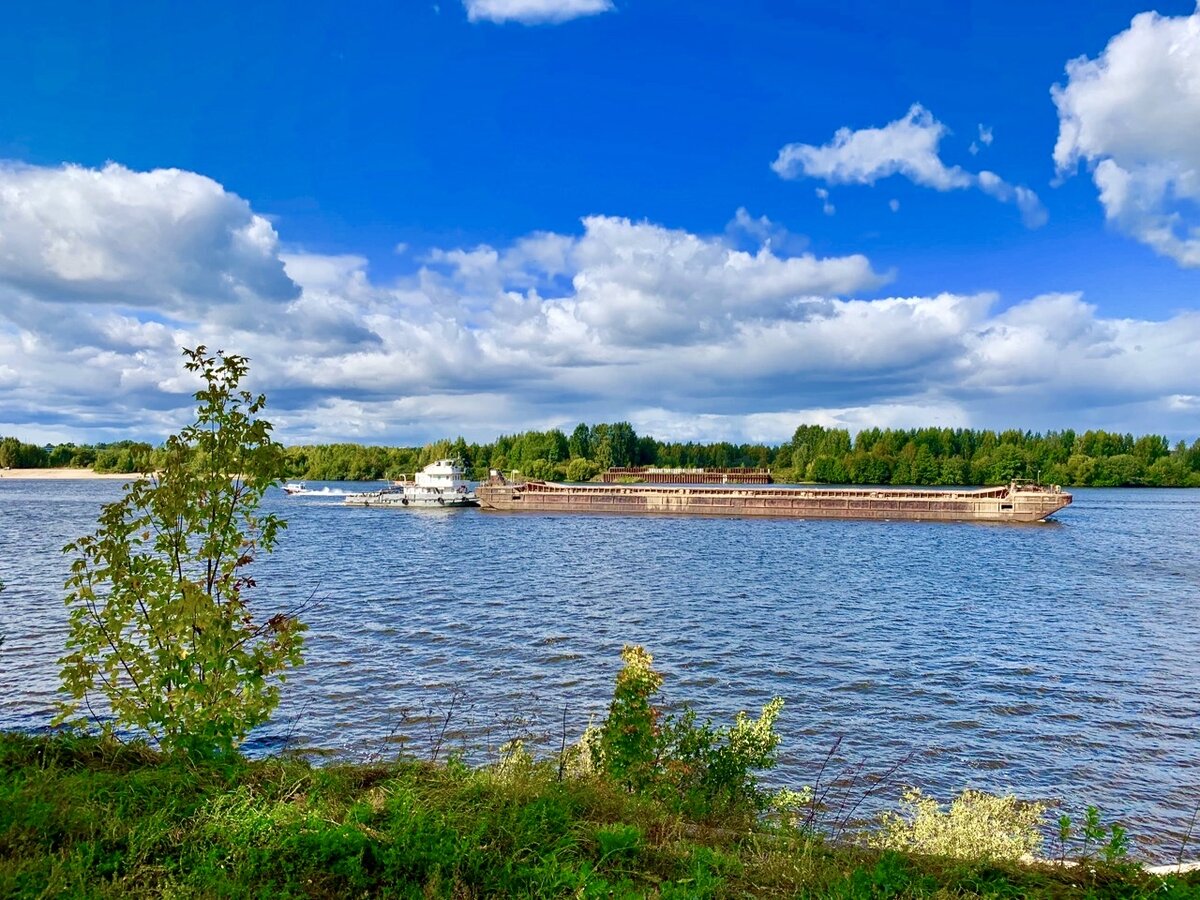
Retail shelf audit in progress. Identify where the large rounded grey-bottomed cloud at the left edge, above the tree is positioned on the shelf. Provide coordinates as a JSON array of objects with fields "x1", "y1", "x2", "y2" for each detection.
[{"x1": 0, "y1": 163, "x2": 296, "y2": 312}]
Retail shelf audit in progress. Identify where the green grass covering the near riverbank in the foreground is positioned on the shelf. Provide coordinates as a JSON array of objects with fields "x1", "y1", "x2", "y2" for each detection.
[{"x1": 0, "y1": 734, "x2": 1200, "y2": 900}]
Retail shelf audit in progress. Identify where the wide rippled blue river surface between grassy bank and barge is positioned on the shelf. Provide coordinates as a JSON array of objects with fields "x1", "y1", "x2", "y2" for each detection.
[{"x1": 0, "y1": 478, "x2": 1200, "y2": 859}]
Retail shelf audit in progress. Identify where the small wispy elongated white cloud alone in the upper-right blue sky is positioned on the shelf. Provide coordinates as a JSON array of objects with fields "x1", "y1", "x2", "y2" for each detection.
[{"x1": 770, "y1": 103, "x2": 1046, "y2": 228}]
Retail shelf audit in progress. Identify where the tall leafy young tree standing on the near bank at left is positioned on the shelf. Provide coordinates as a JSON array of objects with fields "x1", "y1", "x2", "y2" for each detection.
[{"x1": 56, "y1": 347, "x2": 304, "y2": 755}]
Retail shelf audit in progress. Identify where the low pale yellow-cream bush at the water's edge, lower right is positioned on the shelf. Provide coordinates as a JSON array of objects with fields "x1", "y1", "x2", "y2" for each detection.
[{"x1": 870, "y1": 788, "x2": 1045, "y2": 860}]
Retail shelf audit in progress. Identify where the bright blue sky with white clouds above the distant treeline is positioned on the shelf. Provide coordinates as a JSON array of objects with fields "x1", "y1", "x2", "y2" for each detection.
[{"x1": 0, "y1": 0, "x2": 1200, "y2": 445}]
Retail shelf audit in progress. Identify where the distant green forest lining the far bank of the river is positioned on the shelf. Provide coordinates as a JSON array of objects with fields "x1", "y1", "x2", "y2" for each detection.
[{"x1": 0, "y1": 422, "x2": 1200, "y2": 487}]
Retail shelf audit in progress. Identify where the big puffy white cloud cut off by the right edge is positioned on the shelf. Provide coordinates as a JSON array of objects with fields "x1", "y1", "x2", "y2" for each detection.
[{"x1": 1051, "y1": 11, "x2": 1200, "y2": 266}]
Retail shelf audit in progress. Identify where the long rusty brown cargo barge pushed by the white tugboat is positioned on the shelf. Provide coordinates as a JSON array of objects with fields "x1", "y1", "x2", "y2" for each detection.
[{"x1": 475, "y1": 474, "x2": 1072, "y2": 522}]
